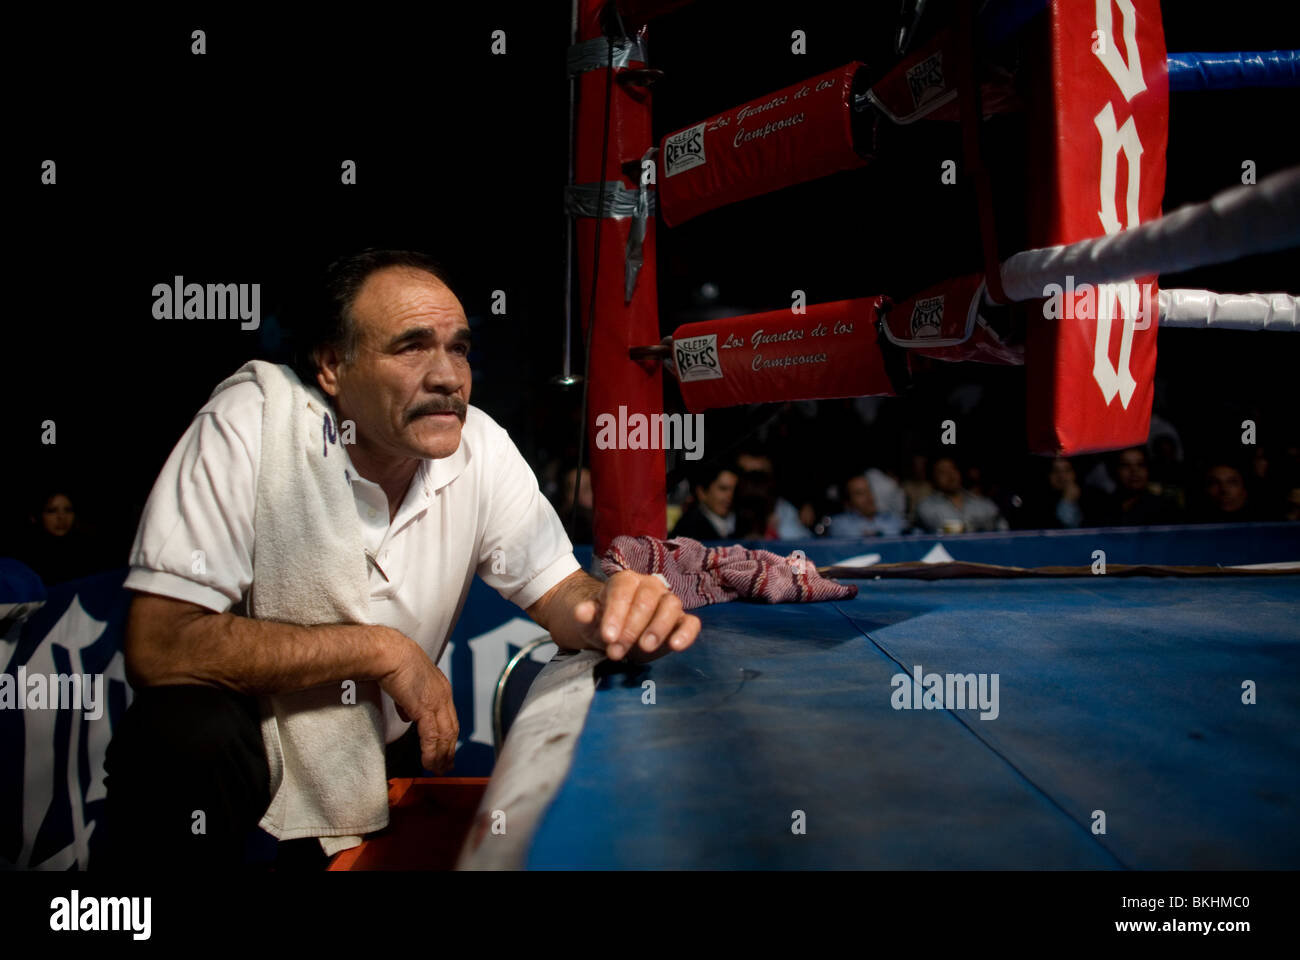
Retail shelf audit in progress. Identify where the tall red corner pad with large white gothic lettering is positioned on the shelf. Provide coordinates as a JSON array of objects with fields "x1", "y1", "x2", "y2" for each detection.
[{"x1": 1026, "y1": 0, "x2": 1169, "y2": 457}]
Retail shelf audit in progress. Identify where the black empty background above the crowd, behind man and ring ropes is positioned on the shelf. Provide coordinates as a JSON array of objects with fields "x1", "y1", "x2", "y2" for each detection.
[{"x1": 0, "y1": 0, "x2": 1300, "y2": 565}]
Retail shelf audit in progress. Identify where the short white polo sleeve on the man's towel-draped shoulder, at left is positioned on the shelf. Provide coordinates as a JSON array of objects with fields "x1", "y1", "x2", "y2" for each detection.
[{"x1": 124, "y1": 381, "x2": 264, "y2": 613}]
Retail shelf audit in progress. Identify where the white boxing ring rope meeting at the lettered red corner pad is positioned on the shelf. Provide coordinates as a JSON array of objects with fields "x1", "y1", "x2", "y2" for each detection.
[{"x1": 1001, "y1": 160, "x2": 1300, "y2": 321}]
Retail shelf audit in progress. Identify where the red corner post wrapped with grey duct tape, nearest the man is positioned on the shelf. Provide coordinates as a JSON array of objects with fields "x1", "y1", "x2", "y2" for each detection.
[{"x1": 573, "y1": 0, "x2": 668, "y2": 555}]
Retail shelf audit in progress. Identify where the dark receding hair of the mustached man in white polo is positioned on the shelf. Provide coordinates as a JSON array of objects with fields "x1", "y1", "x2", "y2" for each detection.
[{"x1": 290, "y1": 248, "x2": 451, "y2": 384}]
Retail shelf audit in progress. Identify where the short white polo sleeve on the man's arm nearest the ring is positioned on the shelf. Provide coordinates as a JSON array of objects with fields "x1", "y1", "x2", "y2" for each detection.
[{"x1": 478, "y1": 411, "x2": 582, "y2": 609}]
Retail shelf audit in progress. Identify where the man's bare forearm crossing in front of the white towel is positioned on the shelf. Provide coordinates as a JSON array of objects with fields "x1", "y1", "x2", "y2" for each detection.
[{"x1": 127, "y1": 597, "x2": 406, "y2": 695}]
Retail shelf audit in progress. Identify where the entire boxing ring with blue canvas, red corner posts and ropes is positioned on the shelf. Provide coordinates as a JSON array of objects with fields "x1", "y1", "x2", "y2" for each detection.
[{"x1": 348, "y1": 0, "x2": 1300, "y2": 869}]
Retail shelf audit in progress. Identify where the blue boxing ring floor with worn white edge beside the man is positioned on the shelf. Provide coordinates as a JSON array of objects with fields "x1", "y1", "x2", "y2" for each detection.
[{"x1": 460, "y1": 524, "x2": 1300, "y2": 869}]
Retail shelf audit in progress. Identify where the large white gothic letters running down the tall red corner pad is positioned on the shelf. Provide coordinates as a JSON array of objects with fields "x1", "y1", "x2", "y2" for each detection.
[{"x1": 1092, "y1": 0, "x2": 1152, "y2": 410}]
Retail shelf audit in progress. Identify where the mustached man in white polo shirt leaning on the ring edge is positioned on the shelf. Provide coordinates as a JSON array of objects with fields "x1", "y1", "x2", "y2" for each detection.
[{"x1": 105, "y1": 251, "x2": 699, "y2": 866}]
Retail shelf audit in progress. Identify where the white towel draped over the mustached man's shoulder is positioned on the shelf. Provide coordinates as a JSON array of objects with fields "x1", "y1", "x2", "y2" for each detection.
[{"x1": 213, "y1": 360, "x2": 389, "y2": 853}]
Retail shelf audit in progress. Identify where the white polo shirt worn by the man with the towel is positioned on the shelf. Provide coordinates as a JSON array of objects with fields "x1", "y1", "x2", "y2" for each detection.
[{"x1": 125, "y1": 380, "x2": 581, "y2": 743}]
